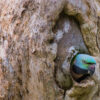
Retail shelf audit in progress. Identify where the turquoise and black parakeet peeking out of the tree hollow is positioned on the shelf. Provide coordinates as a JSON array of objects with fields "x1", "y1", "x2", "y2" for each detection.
[{"x1": 71, "y1": 54, "x2": 96, "y2": 82}]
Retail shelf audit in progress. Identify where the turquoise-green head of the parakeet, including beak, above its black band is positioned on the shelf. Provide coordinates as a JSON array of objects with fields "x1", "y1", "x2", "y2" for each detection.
[{"x1": 74, "y1": 54, "x2": 96, "y2": 75}]
